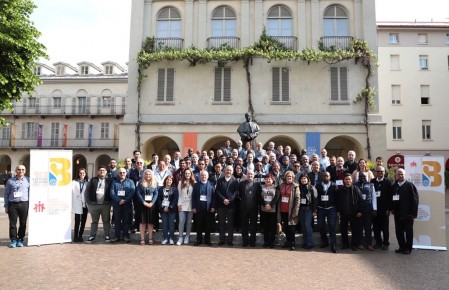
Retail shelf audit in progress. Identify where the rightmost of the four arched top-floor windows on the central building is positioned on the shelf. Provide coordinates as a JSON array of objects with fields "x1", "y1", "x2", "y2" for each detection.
[{"x1": 323, "y1": 5, "x2": 349, "y2": 36}]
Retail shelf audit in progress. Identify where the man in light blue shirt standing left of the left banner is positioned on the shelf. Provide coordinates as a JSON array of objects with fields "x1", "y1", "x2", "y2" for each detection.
[{"x1": 5, "y1": 165, "x2": 30, "y2": 248}]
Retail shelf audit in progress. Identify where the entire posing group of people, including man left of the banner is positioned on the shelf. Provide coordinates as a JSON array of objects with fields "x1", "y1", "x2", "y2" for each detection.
[{"x1": 5, "y1": 140, "x2": 419, "y2": 254}]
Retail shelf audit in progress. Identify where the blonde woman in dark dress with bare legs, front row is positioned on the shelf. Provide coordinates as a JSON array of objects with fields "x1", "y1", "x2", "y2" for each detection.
[{"x1": 136, "y1": 169, "x2": 159, "y2": 245}]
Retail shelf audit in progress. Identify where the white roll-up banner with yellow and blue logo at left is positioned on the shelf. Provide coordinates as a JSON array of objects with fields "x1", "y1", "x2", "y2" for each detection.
[{"x1": 28, "y1": 150, "x2": 72, "y2": 246}]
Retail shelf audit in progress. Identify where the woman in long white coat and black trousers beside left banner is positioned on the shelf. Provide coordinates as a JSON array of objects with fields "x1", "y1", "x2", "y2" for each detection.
[{"x1": 72, "y1": 168, "x2": 88, "y2": 243}]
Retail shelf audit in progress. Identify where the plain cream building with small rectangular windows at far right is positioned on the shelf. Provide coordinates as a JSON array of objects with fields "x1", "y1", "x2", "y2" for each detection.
[{"x1": 377, "y1": 22, "x2": 449, "y2": 167}]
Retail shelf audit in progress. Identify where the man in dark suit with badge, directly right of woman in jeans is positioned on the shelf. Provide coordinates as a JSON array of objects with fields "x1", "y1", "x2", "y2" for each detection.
[{"x1": 316, "y1": 172, "x2": 338, "y2": 253}]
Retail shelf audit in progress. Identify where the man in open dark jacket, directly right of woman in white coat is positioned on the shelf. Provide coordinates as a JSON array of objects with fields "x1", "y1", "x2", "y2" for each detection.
[{"x1": 84, "y1": 165, "x2": 112, "y2": 243}]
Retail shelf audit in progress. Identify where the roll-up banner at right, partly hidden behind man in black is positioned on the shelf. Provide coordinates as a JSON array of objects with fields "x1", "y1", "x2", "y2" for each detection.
[{"x1": 404, "y1": 156, "x2": 447, "y2": 250}]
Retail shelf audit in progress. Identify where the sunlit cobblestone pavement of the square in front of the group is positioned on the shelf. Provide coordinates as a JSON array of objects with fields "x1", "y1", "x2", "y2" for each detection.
[{"x1": 0, "y1": 189, "x2": 449, "y2": 289}]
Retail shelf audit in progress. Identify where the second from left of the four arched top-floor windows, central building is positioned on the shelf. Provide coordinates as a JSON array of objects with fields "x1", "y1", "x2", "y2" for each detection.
[{"x1": 212, "y1": 6, "x2": 237, "y2": 37}]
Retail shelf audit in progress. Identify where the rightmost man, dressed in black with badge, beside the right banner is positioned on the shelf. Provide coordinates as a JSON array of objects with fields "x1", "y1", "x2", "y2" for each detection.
[{"x1": 392, "y1": 169, "x2": 419, "y2": 255}]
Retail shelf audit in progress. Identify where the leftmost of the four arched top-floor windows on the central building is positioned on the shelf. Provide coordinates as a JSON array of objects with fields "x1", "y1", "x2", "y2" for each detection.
[{"x1": 157, "y1": 7, "x2": 181, "y2": 38}]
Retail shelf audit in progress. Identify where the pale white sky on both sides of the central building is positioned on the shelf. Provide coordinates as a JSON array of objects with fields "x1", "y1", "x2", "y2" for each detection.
[{"x1": 31, "y1": 0, "x2": 449, "y2": 65}]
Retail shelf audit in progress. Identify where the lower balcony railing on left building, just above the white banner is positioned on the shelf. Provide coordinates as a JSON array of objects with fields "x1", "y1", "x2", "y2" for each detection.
[{"x1": 0, "y1": 138, "x2": 118, "y2": 149}]
